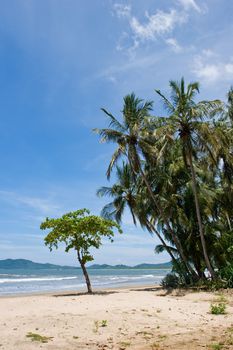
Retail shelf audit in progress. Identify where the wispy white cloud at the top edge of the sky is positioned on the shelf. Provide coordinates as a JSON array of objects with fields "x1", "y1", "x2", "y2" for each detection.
[{"x1": 113, "y1": 0, "x2": 204, "y2": 55}]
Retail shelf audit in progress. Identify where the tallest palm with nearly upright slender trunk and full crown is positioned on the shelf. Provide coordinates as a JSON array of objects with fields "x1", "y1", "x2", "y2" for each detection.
[{"x1": 155, "y1": 78, "x2": 222, "y2": 278}]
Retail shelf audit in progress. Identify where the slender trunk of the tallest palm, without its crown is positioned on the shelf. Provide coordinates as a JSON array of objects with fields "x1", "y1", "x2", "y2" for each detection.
[{"x1": 188, "y1": 151, "x2": 215, "y2": 279}]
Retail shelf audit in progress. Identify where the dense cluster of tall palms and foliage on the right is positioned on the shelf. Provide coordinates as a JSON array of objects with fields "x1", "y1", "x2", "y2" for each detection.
[{"x1": 95, "y1": 79, "x2": 233, "y2": 284}]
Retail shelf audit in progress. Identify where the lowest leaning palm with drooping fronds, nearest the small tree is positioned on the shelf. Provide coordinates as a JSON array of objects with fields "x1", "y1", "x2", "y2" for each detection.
[{"x1": 97, "y1": 162, "x2": 178, "y2": 264}]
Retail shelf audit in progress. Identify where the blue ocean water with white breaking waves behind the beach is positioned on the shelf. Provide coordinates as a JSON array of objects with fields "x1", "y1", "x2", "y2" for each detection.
[{"x1": 0, "y1": 268, "x2": 169, "y2": 296}]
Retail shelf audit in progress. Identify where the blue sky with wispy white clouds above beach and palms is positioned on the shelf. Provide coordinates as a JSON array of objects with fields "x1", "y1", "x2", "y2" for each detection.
[{"x1": 0, "y1": 0, "x2": 233, "y2": 265}]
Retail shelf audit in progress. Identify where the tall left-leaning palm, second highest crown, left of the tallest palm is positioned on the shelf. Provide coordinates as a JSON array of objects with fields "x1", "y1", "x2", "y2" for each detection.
[{"x1": 94, "y1": 93, "x2": 196, "y2": 275}]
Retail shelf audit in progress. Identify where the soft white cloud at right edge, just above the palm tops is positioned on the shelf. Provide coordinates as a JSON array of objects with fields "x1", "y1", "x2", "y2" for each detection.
[{"x1": 192, "y1": 50, "x2": 233, "y2": 84}]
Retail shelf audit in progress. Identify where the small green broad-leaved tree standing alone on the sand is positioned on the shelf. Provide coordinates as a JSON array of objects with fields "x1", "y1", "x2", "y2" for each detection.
[{"x1": 40, "y1": 209, "x2": 122, "y2": 293}]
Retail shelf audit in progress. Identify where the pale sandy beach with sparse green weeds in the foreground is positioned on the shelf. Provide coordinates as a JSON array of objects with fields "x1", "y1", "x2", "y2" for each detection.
[{"x1": 0, "y1": 286, "x2": 233, "y2": 350}]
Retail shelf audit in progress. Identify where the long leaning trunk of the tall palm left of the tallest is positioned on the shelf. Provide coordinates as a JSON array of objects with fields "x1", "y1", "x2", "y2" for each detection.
[{"x1": 139, "y1": 164, "x2": 199, "y2": 280}]
